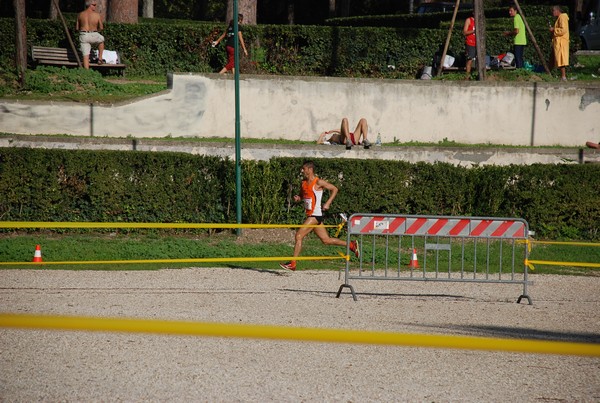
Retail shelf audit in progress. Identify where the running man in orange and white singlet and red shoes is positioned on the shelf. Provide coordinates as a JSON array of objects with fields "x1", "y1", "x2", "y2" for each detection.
[{"x1": 279, "y1": 161, "x2": 360, "y2": 271}]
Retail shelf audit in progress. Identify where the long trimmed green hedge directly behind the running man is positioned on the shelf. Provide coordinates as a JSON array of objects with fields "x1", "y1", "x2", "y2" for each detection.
[{"x1": 0, "y1": 148, "x2": 600, "y2": 240}]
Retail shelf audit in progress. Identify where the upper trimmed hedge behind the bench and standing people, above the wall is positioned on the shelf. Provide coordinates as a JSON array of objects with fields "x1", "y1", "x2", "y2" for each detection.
[{"x1": 0, "y1": 18, "x2": 578, "y2": 78}]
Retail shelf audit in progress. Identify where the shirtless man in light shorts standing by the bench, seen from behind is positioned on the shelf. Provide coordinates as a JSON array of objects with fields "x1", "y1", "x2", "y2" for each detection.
[{"x1": 75, "y1": 0, "x2": 104, "y2": 69}]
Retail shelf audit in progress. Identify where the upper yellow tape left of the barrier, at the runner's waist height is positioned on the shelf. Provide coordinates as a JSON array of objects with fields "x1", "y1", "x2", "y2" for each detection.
[{"x1": 0, "y1": 221, "x2": 337, "y2": 228}]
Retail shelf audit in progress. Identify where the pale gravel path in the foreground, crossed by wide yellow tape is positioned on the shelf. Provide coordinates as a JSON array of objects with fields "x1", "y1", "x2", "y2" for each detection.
[{"x1": 0, "y1": 268, "x2": 600, "y2": 402}]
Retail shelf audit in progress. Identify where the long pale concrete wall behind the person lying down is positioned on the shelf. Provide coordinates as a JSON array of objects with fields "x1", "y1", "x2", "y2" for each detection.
[{"x1": 0, "y1": 74, "x2": 600, "y2": 147}]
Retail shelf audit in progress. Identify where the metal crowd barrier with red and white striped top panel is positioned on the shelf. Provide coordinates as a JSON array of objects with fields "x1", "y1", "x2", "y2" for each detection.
[{"x1": 337, "y1": 214, "x2": 532, "y2": 305}]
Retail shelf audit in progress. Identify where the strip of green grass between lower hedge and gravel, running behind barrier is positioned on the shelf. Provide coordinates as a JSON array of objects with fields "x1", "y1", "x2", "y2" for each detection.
[{"x1": 0, "y1": 230, "x2": 600, "y2": 276}]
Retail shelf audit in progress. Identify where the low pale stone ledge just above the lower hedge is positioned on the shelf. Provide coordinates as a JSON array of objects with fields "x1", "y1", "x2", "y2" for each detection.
[{"x1": 0, "y1": 135, "x2": 600, "y2": 167}]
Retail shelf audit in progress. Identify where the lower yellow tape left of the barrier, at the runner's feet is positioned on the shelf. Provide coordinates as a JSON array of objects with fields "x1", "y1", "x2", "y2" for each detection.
[{"x1": 0, "y1": 253, "x2": 347, "y2": 266}]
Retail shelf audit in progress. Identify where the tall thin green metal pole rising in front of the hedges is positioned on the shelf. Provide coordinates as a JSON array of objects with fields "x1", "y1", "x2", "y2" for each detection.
[{"x1": 233, "y1": 0, "x2": 242, "y2": 236}]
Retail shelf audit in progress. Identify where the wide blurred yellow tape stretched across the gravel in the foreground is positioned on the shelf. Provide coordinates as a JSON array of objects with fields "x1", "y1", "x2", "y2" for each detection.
[{"x1": 0, "y1": 314, "x2": 600, "y2": 357}]
